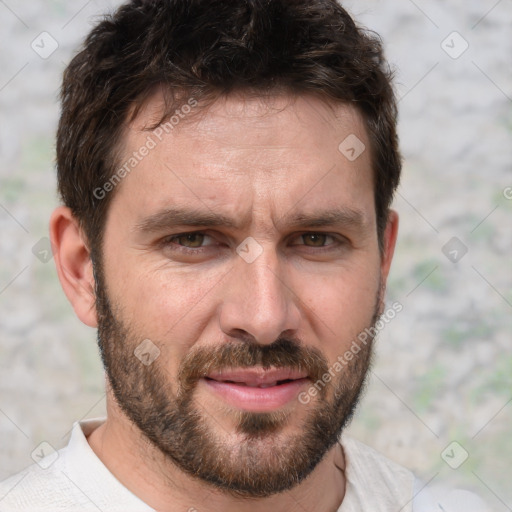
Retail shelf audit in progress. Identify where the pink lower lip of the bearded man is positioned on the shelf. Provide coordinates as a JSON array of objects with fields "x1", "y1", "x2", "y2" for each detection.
[{"x1": 201, "y1": 378, "x2": 309, "y2": 412}]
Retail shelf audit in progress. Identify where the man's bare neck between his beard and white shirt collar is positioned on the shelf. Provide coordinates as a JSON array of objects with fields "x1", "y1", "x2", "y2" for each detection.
[{"x1": 88, "y1": 400, "x2": 345, "y2": 512}]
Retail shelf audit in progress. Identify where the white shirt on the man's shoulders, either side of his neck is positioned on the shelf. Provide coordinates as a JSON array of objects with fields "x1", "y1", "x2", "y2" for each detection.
[{"x1": 0, "y1": 418, "x2": 480, "y2": 512}]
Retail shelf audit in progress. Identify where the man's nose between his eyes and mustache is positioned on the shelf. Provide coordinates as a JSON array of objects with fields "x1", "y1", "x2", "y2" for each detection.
[{"x1": 220, "y1": 243, "x2": 300, "y2": 345}]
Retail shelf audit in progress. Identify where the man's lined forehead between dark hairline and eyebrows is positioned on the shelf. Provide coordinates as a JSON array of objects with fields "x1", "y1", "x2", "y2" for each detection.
[{"x1": 114, "y1": 93, "x2": 373, "y2": 230}]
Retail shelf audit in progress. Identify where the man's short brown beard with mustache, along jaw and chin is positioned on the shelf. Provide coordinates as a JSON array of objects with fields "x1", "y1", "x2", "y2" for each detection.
[{"x1": 95, "y1": 260, "x2": 381, "y2": 498}]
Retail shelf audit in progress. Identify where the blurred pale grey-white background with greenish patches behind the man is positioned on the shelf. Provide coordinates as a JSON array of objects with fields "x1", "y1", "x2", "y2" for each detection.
[{"x1": 0, "y1": 0, "x2": 512, "y2": 511}]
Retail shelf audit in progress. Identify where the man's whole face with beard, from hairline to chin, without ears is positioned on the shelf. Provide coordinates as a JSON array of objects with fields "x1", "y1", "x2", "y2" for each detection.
[{"x1": 97, "y1": 91, "x2": 390, "y2": 496}]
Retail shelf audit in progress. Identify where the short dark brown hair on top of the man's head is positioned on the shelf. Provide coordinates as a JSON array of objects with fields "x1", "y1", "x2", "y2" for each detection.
[{"x1": 57, "y1": 0, "x2": 401, "y2": 256}]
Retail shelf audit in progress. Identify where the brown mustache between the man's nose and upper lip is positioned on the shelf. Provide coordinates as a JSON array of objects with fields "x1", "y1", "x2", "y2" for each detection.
[{"x1": 178, "y1": 338, "x2": 329, "y2": 393}]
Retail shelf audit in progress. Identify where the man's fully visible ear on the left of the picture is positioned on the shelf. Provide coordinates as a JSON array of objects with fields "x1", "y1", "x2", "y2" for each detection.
[{"x1": 50, "y1": 206, "x2": 98, "y2": 327}]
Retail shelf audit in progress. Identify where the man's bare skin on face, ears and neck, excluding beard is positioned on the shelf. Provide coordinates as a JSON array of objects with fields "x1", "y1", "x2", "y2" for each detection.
[{"x1": 50, "y1": 93, "x2": 398, "y2": 512}]
